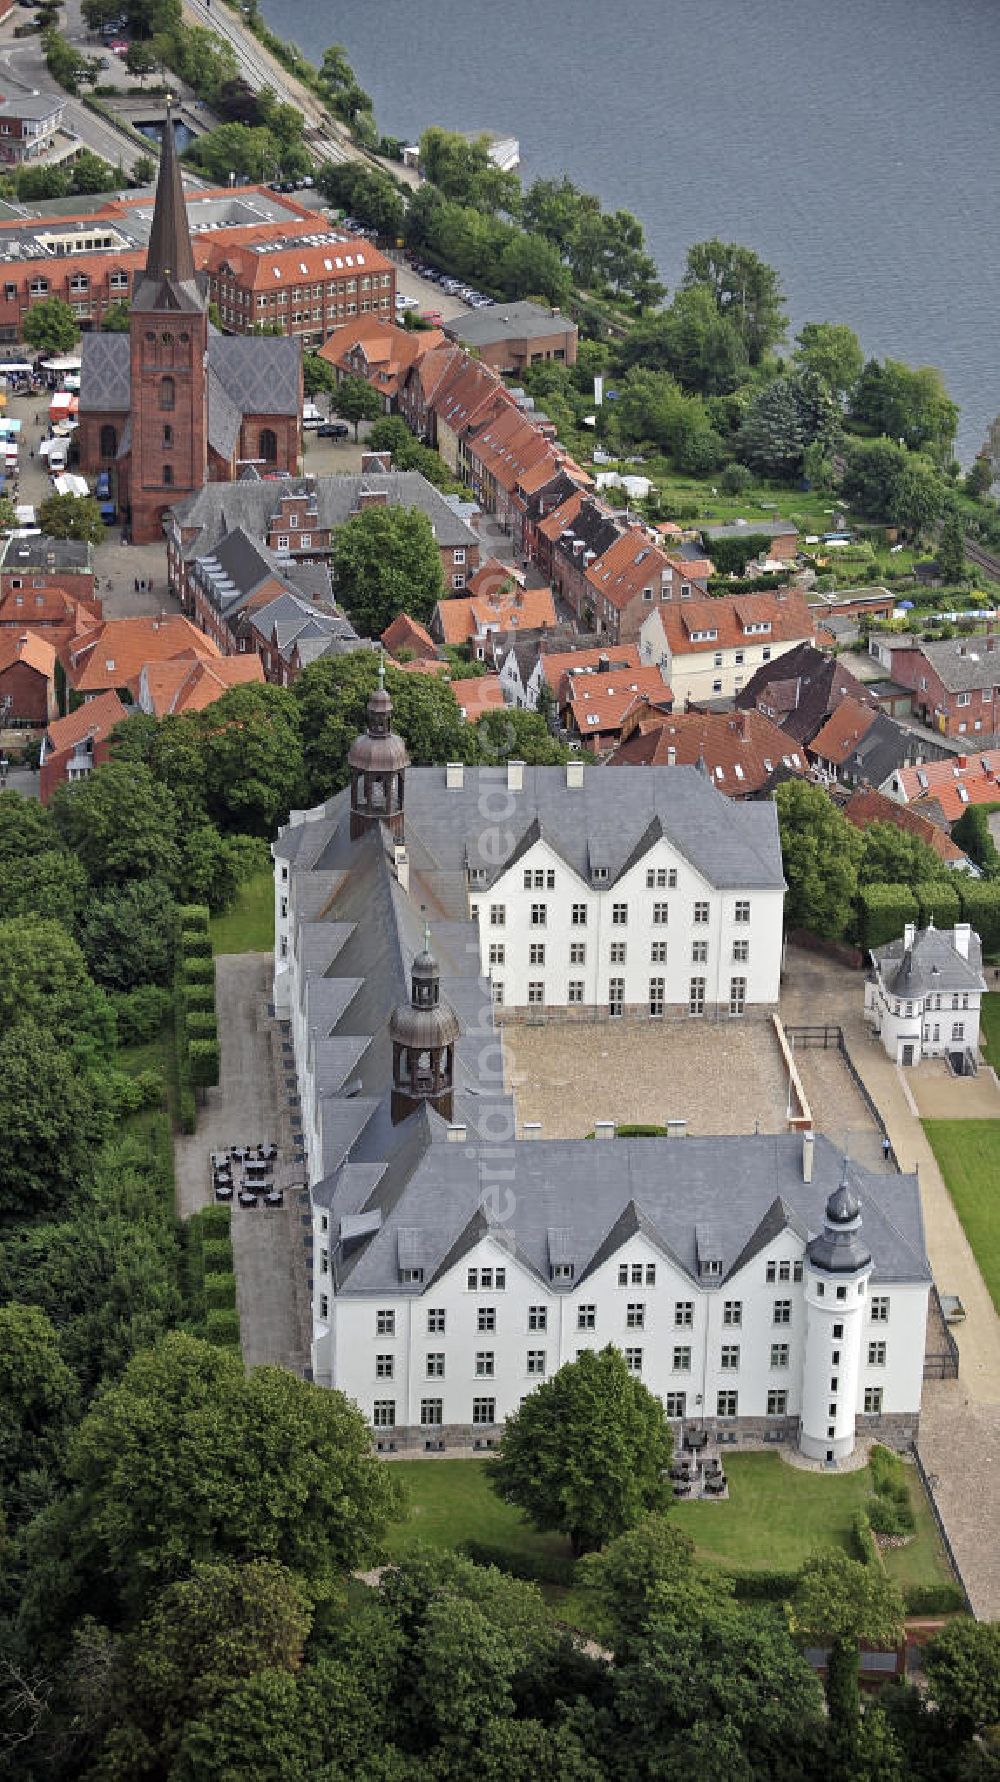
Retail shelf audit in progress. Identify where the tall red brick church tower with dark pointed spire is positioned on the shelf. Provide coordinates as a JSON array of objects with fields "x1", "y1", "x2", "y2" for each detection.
[{"x1": 128, "y1": 110, "x2": 209, "y2": 544}]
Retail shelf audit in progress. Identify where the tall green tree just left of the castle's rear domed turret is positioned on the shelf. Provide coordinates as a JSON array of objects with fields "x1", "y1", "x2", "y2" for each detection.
[{"x1": 196, "y1": 686, "x2": 303, "y2": 836}]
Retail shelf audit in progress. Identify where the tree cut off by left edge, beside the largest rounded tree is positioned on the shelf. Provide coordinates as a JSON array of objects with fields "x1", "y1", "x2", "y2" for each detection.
[{"x1": 0, "y1": 1304, "x2": 77, "y2": 1511}]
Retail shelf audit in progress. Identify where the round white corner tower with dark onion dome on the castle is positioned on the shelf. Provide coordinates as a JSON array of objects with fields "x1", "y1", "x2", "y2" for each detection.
[{"x1": 799, "y1": 1158, "x2": 872, "y2": 1461}]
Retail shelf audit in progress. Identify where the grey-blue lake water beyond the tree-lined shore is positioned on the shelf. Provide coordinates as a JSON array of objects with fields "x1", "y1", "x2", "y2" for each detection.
[{"x1": 264, "y1": 0, "x2": 1000, "y2": 460}]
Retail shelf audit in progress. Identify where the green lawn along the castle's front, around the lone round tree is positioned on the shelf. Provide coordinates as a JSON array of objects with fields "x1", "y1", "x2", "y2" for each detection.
[{"x1": 379, "y1": 1454, "x2": 950, "y2": 1613}]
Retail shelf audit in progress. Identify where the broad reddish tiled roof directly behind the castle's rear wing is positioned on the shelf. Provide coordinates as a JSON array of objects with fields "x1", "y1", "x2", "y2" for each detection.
[{"x1": 611, "y1": 711, "x2": 807, "y2": 798}]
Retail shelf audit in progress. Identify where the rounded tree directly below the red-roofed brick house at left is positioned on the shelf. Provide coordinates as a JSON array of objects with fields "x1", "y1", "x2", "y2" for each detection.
[{"x1": 50, "y1": 755, "x2": 180, "y2": 884}]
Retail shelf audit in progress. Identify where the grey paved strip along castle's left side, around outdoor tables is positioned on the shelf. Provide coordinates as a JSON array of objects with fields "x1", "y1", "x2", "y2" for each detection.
[{"x1": 175, "y1": 953, "x2": 308, "y2": 1374}]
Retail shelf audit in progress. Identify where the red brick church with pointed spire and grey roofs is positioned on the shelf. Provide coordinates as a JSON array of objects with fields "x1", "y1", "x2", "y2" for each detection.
[{"x1": 78, "y1": 128, "x2": 301, "y2": 544}]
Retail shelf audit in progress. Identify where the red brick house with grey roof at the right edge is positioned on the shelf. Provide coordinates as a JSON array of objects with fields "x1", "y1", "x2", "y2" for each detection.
[{"x1": 868, "y1": 634, "x2": 1000, "y2": 743}]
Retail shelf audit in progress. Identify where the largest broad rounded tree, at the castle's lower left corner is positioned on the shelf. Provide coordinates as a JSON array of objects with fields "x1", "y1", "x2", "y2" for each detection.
[{"x1": 68, "y1": 1335, "x2": 401, "y2": 1606}]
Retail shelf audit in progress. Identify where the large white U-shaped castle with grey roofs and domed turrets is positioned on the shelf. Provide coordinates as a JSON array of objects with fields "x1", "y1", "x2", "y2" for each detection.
[{"x1": 273, "y1": 673, "x2": 930, "y2": 1461}]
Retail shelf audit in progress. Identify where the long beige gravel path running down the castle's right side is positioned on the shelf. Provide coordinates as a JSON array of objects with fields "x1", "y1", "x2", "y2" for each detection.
[{"x1": 781, "y1": 948, "x2": 1000, "y2": 1620}]
